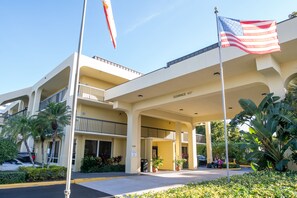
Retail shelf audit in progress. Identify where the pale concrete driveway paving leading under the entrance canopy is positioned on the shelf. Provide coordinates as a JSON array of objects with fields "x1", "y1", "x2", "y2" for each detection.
[{"x1": 80, "y1": 168, "x2": 250, "y2": 196}]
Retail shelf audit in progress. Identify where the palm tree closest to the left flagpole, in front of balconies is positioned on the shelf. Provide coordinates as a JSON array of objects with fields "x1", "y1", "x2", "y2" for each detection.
[{"x1": 39, "y1": 102, "x2": 71, "y2": 167}]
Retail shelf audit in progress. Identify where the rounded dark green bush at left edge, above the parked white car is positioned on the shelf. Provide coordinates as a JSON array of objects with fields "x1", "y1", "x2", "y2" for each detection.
[{"x1": 0, "y1": 138, "x2": 18, "y2": 165}]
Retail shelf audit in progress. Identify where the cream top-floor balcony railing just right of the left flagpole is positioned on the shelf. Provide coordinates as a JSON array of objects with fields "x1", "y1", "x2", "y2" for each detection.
[{"x1": 78, "y1": 84, "x2": 110, "y2": 103}]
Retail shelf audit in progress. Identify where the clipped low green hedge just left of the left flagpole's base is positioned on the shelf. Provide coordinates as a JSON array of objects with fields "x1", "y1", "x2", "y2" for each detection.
[{"x1": 19, "y1": 166, "x2": 67, "y2": 182}]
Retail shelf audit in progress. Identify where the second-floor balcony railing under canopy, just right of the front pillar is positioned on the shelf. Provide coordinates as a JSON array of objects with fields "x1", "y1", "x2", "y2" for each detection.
[{"x1": 141, "y1": 127, "x2": 175, "y2": 140}]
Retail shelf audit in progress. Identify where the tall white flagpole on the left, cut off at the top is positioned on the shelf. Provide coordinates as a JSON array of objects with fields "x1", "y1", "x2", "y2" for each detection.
[{"x1": 64, "y1": 0, "x2": 87, "y2": 198}]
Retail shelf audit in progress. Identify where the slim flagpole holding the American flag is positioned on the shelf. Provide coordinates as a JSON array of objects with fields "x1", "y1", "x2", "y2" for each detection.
[{"x1": 214, "y1": 7, "x2": 230, "y2": 182}]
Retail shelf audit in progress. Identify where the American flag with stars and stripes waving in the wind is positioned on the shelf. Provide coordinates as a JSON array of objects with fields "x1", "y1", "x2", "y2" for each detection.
[{"x1": 218, "y1": 17, "x2": 280, "y2": 54}]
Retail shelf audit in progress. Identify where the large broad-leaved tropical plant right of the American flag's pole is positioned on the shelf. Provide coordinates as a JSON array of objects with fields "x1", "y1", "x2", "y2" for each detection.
[{"x1": 231, "y1": 93, "x2": 297, "y2": 171}]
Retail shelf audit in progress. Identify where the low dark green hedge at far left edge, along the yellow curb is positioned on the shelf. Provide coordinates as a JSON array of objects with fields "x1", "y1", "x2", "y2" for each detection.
[{"x1": 0, "y1": 171, "x2": 26, "y2": 184}]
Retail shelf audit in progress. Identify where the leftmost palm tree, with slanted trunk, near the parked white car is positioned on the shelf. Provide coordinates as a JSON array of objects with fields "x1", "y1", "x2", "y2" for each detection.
[{"x1": 2, "y1": 115, "x2": 35, "y2": 167}]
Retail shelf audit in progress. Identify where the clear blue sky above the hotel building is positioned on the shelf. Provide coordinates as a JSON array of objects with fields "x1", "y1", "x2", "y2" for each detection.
[{"x1": 0, "y1": 0, "x2": 297, "y2": 94}]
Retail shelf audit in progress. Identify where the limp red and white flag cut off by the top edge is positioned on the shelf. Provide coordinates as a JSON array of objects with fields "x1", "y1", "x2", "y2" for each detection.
[{"x1": 102, "y1": 0, "x2": 117, "y2": 48}]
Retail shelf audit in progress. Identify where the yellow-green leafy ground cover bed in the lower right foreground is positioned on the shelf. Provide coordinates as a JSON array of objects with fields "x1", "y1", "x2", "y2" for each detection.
[{"x1": 130, "y1": 171, "x2": 297, "y2": 198}]
